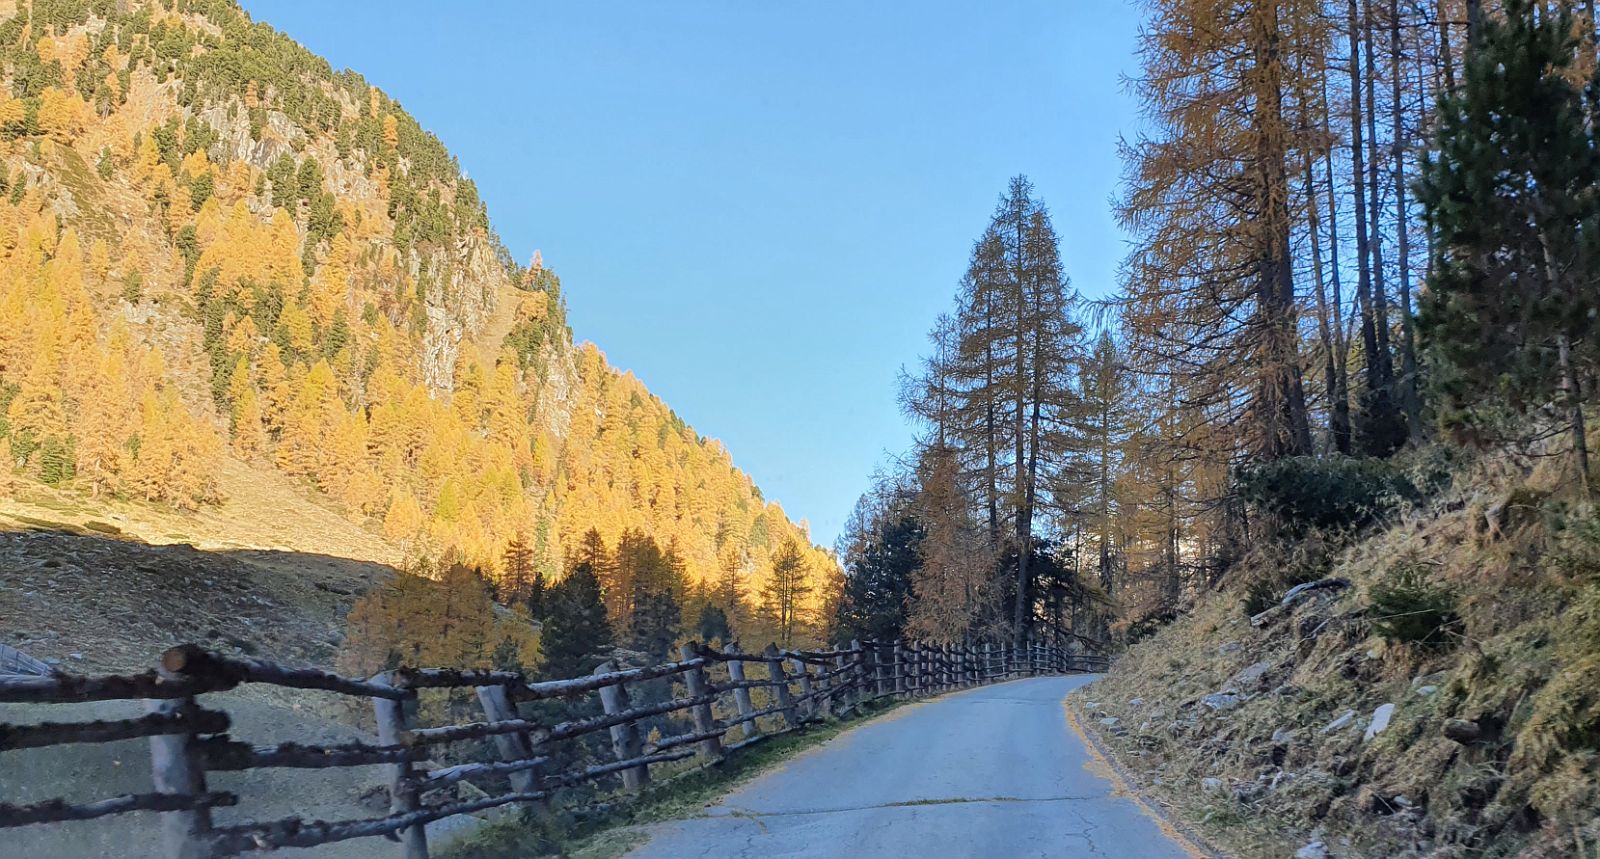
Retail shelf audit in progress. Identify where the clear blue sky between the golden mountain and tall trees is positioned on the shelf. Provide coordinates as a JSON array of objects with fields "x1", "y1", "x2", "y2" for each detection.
[{"x1": 236, "y1": 0, "x2": 1138, "y2": 544}]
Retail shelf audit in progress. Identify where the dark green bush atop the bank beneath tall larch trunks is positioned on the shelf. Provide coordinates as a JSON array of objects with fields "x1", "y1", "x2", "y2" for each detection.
[{"x1": 1235, "y1": 456, "x2": 1418, "y2": 529}]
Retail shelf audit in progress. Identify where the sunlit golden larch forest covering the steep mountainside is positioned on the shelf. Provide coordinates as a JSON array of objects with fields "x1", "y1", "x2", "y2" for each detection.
[{"x1": 0, "y1": 0, "x2": 838, "y2": 662}]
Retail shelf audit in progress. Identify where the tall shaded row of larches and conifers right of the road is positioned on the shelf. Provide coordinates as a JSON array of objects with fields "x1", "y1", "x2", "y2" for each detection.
[{"x1": 840, "y1": 0, "x2": 1600, "y2": 641}]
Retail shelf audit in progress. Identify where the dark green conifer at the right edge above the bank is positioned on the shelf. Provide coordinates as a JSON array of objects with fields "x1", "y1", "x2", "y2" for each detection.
[{"x1": 1416, "y1": 0, "x2": 1600, "y2": 491}]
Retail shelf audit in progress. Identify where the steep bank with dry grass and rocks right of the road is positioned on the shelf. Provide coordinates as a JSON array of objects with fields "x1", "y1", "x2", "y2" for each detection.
[{"x1": 1074, "y1": 449, "x2": 1600, "y2": 859}]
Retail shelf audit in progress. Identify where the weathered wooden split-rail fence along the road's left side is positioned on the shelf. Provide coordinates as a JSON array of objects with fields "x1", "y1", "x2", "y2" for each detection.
[{"x1": 0, "y1": 641, "x2": 1106, "y2": 859}]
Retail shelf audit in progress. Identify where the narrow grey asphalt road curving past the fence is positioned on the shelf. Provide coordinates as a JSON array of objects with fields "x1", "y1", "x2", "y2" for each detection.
[{"x1": 629, "y1": 677, "x2": 1205, "y2": 859}]
